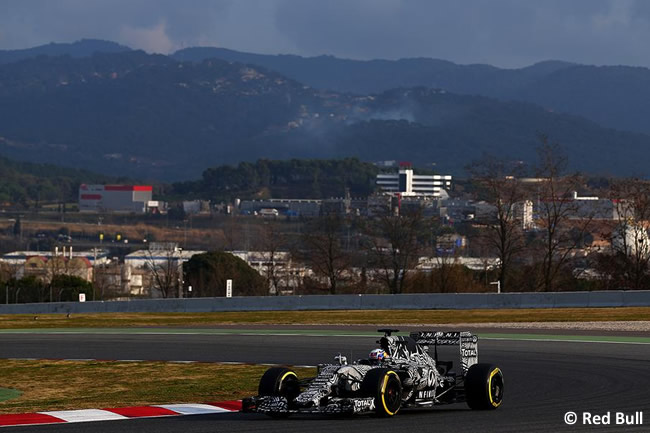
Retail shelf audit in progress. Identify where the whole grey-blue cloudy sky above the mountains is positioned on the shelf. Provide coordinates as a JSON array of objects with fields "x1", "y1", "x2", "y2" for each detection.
[{"x1": 0, "y1": 0, "x2": 650, "y2": 67}]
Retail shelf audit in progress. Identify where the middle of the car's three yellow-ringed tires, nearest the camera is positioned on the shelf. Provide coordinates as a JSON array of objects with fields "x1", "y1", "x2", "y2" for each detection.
[{"x1": 361, "y1": 368, "x2": 402, "y2": 417}]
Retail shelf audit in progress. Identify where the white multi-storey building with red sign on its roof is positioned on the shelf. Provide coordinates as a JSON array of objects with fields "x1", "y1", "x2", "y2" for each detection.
[{"x1": 377, "y1": 163, "x2": 451, "y2": 197}]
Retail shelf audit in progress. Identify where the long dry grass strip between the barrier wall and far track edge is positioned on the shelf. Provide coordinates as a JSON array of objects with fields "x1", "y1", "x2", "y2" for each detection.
[{"x1": 0, "y1": 307, "x2": 650, "y2": 329}]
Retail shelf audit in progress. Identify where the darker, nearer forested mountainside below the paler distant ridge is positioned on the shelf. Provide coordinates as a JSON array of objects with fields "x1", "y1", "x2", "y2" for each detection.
[{"x1": 0, "y1": 51, "x2": 650, "y2": 182}]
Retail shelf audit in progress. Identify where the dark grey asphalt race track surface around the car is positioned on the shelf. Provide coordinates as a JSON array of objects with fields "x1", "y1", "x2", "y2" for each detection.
[{"x1": 0, "y1": 329, "x2": 650, "y2": 433}]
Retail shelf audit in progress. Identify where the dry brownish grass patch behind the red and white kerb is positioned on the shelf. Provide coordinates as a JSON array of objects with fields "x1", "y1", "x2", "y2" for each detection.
[{"x1": 0, "y1": 360, "x2": 315, "y2": 414}]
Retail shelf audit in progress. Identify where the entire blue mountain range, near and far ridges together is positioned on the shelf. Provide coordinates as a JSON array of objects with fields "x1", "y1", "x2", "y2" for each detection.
[{"x1": 0, "y1": 40, "x2": 650, "y2": 180}]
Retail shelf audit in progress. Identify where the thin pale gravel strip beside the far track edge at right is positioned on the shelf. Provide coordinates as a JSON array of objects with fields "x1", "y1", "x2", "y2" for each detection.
[{"x1": 412, "y1": 320, "x2": 650, "y2": 332}]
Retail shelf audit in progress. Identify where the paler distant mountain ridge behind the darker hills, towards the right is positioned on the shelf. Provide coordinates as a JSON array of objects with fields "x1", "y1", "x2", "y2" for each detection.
[{"x1": 172, "y1": 47, "x2": 650, "y2": 133}]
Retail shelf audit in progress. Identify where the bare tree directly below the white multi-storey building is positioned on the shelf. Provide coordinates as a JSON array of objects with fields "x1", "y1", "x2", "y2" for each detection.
[{"x1": 367, "y1": 208, "x2": 428, "y2": 294}]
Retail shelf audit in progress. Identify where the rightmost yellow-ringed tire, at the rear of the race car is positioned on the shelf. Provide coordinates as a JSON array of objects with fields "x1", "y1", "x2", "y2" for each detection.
[{"x1": 465, "y1": 364, "x2": 503, "y2": 410}]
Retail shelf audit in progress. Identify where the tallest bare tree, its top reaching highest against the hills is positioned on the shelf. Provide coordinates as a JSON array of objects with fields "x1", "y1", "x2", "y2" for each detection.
[{"x1": 537, "y1": 136, "x2": 593, "y2": 291}]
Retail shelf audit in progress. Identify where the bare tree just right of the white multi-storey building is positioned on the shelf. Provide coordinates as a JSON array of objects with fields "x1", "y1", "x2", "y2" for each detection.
[{"x1": 470, "y1": 156, "x2": 526, "y2": 290}]
